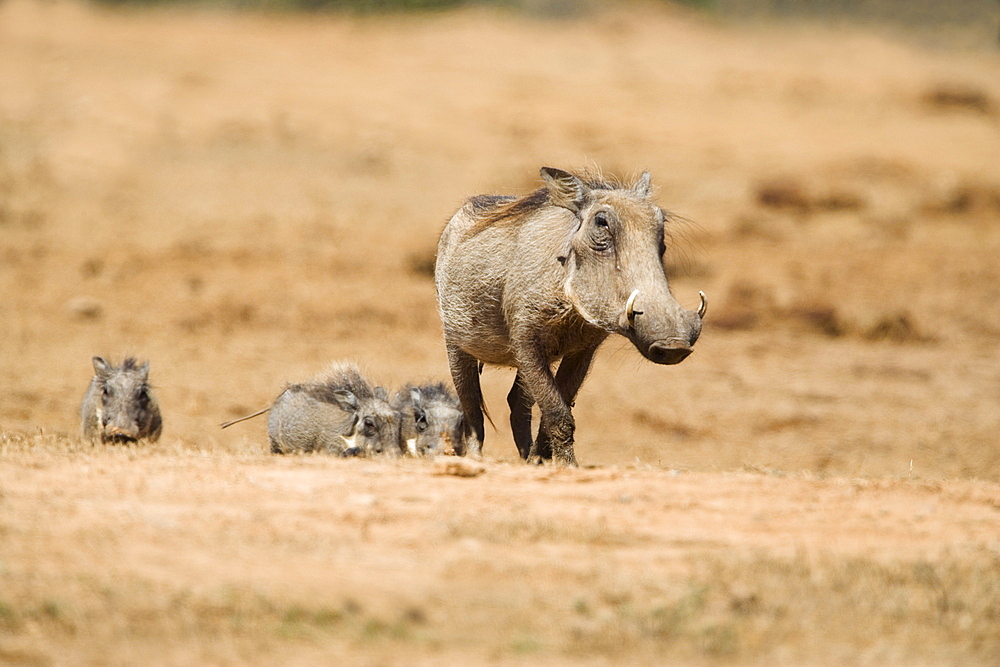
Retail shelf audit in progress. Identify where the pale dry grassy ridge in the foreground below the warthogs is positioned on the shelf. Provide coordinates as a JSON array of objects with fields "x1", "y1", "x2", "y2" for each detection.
[{"x1": 0, "y1": 435, "x2": 1000, "y2": 665}]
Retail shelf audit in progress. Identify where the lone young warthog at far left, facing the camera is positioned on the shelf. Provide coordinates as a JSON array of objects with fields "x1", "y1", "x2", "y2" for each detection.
[{"x1": 80, "y1": 357, "x2": 163, "y2": 442}]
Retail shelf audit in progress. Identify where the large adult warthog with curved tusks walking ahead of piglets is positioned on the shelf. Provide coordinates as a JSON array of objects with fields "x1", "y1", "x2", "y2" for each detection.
[{"x1": 434, "y1": 167, "x2": 706, "y2": 465}]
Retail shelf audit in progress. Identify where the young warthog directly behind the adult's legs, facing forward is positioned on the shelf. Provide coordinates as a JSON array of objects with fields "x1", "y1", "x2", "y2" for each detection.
[{"x1": 392, "y1": 382, "x2": 465, "y2": 456}]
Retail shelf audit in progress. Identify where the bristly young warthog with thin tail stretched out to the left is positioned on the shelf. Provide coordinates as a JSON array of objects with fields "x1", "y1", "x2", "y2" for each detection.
[{"x1": 270, "y1": 362, "x2": 402, "y2": 456}]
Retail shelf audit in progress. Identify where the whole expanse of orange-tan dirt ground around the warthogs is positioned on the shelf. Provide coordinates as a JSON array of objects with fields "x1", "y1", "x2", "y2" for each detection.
[{"x1": 0, "y1": 0, "x2": 1000, "y2": 665}]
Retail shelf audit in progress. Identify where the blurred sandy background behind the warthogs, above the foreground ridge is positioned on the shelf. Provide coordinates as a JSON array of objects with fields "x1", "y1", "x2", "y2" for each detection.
[{"x1": 0, "y1": 0, "x2": 1000, "y2": 480}]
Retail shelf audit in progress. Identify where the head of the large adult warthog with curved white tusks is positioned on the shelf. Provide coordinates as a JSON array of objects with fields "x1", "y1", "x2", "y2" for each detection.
[{"x1": 541, "y1": 167, "x2": 707, "y2": 364}]
